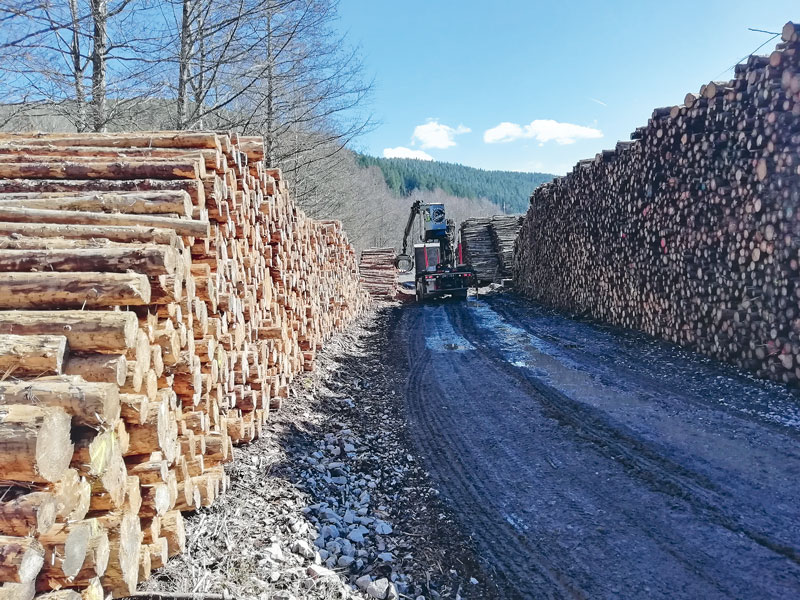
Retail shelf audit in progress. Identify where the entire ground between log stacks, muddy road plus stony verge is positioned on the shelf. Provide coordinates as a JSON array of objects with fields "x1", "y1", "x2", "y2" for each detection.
[{"x1": 136, "y1": 294, "x2": 800, "y2": 600}]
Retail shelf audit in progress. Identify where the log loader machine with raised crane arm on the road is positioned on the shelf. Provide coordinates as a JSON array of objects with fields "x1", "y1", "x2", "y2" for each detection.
[{"x1": 395, "y1": 200, "x2": 478, "y2": 301}]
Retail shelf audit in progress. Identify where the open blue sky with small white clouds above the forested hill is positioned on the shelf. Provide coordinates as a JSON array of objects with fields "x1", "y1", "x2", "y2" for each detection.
[{"x1": 339, "y1": 0, "x2": 800, "y2": 174}]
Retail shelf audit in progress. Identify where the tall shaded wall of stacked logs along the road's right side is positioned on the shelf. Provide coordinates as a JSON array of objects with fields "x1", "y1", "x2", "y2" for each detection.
[{"x1": 514, "y1": 23, "x2": 800, "y2": 385}]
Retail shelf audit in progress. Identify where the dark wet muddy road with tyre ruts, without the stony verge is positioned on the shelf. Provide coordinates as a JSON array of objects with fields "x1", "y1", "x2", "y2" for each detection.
[{"x1": 389, "y1": 295, "x2": 800, "y2": 599}]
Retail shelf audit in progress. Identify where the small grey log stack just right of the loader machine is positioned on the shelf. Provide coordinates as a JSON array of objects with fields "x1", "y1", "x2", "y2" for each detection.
[{"x1": 461, "y1": 215, "x2": 522, "y2": 283}]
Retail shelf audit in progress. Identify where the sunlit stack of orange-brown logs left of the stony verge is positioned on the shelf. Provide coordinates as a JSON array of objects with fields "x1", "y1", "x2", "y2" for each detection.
[{"x1": 0, "y1": 132, "x2": 369, "y2": 600}]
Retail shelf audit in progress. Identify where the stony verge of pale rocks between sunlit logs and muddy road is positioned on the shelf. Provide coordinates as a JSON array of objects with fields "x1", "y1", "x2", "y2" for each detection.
[{"x1": 142, "y1": 305, "x2": 499, "y2": 600}]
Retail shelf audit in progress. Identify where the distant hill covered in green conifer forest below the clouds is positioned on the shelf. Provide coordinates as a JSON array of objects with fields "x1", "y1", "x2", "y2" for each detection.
[{"x1": 357, "y1": 154, "x2": 554, "y2": 213}]
